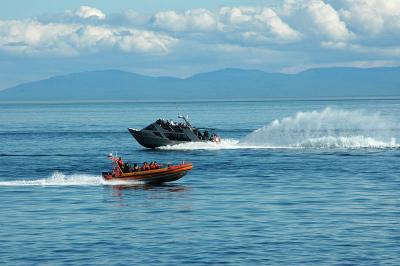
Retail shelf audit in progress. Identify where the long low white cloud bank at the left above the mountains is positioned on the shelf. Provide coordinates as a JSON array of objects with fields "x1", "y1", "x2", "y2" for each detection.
[{"x1": 0, "y1": 20, "x2": 178, "y2": 56}]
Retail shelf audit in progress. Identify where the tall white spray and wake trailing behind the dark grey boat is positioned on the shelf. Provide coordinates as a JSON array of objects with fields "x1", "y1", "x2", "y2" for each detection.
[{"x1": 161, "y1": 108, "x2": 400, "y2": 150}]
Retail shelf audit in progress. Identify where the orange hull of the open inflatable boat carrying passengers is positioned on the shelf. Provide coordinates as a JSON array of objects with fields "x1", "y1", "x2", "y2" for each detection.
[{"x1": 102, "y1": 163, "x2": 193, "y2": 184}]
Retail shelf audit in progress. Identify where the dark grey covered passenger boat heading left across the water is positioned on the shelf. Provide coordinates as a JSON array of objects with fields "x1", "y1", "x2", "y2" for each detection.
[{"x1": 128, "y1": 115, "x2": 220, "y2": 148}]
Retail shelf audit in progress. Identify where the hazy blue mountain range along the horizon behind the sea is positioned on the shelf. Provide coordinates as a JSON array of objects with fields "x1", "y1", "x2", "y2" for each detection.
[{"x1": 0, "y1": 67, "x2": 400, "y2": 101}]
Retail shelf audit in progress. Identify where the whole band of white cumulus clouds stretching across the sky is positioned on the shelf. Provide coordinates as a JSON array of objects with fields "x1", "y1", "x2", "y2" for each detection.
[{"x1": 0, "y1": 0, "x2": 400, "y2": 66}]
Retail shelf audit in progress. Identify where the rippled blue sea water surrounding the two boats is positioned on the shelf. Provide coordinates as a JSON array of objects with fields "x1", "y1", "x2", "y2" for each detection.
[{"x1": 0, "y1": 99, "x2": 400, "y2": 265}]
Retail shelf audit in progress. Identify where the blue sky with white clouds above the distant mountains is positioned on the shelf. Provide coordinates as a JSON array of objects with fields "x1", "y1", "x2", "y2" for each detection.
[{"x1": 0, "y1": 0, "x2": 400, "y2": 89}]
